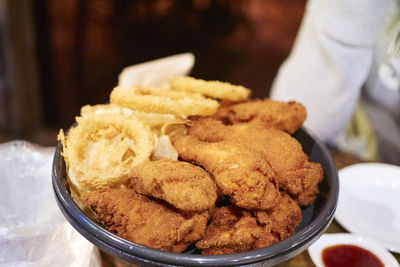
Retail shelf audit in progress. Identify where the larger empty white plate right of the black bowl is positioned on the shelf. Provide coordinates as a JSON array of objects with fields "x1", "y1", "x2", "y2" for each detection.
[{"x1": 335, "y1": 163, "x2": 400, "y2": 253}]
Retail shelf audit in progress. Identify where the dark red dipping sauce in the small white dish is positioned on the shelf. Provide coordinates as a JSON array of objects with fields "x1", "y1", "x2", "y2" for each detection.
[{"x1": 322, "y1": 245, "x2": 384, "y2": 267}]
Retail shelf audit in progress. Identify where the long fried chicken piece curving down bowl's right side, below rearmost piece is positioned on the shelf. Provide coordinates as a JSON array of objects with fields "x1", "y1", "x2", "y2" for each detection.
[{"x1": 188, "y1": 117, "x2": 323, "y2": 206}]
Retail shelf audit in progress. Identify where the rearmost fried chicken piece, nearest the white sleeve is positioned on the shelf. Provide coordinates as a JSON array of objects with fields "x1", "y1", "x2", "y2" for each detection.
[{"x1": 213, "y1": 99, "x2": 307, "y2": 134}]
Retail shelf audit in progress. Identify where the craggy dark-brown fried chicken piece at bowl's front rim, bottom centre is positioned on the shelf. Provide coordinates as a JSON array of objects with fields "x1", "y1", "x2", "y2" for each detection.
[{"x1": 196, "y1": 205, "x2": 279, "y2": 255}]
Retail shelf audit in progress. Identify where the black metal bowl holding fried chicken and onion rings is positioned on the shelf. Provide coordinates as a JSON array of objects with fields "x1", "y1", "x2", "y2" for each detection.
[{"x1": 52, "y1": 128, "x2": 339, "y2": 266}]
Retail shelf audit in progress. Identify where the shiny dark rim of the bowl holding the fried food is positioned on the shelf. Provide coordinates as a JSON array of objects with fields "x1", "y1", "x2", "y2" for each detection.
[{"x1": 52, "y1": 127, "x2": 339, "y2": 266}]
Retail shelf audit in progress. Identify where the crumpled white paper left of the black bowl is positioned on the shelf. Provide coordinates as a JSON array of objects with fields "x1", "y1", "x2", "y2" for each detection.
[{"x1": 0, "y1": 141, "x2": 101, "y2": 267}]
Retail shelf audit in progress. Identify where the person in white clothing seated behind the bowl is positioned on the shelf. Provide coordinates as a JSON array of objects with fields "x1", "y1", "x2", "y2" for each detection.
[{"x1": 270, "y1": 0, "x2": 400, "y2": 165}]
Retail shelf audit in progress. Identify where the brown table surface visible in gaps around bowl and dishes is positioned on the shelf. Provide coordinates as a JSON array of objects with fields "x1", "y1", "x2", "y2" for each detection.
[{"x1": 102, "y1": 150, "x2": 400, "y2": 267}]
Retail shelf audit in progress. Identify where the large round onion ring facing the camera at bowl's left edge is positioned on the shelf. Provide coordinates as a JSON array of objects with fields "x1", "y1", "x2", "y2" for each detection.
[{"x1": 58, "y1": 114, "x2": 154, "y2": 191}]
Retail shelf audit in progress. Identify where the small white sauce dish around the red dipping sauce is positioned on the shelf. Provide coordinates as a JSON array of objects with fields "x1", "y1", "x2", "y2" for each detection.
[{"x1": 308, "y1": 234, "x2": 399, "y2": 267}]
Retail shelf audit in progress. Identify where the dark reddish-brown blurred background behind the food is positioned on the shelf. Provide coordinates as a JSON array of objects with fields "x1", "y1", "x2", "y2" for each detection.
[{"x1": 0, "y1": 0, "x2": 306, "y2": 145}]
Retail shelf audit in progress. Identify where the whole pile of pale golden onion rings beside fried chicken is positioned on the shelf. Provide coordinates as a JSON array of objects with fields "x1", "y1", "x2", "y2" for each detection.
[{"x1": 58, "y1": 77, "x2": 250, "y2": 191}]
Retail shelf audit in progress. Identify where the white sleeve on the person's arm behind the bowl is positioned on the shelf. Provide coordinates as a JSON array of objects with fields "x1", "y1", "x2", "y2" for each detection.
[{"x1": 270, "y1": 0, "x2": 390, "y2": 141}]
